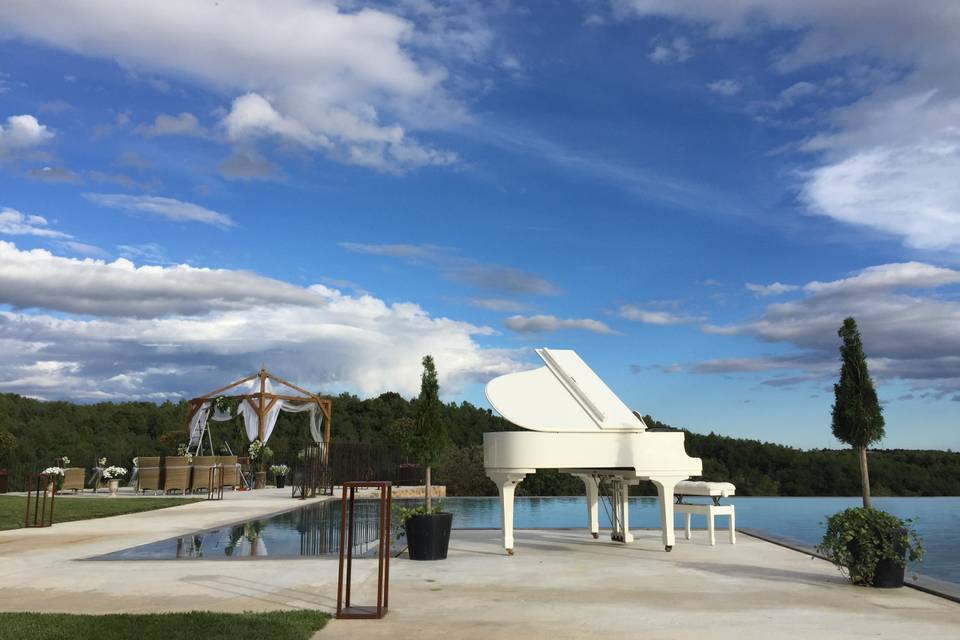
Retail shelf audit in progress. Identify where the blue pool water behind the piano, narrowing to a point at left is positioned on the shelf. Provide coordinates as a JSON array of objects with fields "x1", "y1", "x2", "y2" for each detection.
[{"x1": 96, "y1": 497, "x2": 960, "y2": 583}]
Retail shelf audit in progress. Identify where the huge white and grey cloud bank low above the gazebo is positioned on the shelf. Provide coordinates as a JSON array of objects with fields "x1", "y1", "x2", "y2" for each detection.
[{"x1": 0, "y1": 243, "x2": 522, "y2": 399}]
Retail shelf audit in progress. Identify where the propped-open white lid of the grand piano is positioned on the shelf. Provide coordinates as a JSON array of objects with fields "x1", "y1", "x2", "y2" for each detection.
[{"x1": 486, "y1": 349, "x2": 646, "y2": 431}]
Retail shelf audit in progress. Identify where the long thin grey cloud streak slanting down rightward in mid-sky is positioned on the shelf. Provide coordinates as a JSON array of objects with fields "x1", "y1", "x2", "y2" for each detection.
[{"x1": 340, "y1": 242, "x2": 560, "y2": 296}]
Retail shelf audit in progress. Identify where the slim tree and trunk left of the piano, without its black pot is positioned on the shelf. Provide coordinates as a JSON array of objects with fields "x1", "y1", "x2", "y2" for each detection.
[{"x1": 392, "y1": 356, "x2": 447, "y2": 513}]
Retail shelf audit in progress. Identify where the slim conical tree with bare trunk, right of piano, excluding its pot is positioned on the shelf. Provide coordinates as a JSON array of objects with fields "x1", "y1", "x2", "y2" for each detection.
[{"x1": 832, "y1": 318, "x2": 884, "y2": 508}]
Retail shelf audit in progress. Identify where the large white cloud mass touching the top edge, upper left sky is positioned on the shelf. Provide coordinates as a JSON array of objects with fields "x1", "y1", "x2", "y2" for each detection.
[{"x1": 0, "y1": 0, "x2": 464, "y2": 171}]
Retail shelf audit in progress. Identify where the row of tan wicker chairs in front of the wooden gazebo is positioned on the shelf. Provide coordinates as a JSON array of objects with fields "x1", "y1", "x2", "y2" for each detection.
[{"x1": 137, "y1": 456, "x2": 243, "y2": 493}]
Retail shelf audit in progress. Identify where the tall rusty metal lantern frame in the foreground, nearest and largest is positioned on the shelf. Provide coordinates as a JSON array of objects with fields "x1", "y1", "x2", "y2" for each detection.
[{"x1": 337, "y1": 481, "x2": 393, "y2": 620}]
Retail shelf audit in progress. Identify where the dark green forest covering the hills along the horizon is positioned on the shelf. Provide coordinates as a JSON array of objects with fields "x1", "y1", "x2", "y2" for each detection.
[{"x1": 0, "y1": 393, "x2": 960, "y2": 496}]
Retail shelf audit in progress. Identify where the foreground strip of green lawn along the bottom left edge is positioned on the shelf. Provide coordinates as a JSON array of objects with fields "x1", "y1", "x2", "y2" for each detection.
[{"x1": 0, "y1": 608, "x2": 330, "y2": 640}]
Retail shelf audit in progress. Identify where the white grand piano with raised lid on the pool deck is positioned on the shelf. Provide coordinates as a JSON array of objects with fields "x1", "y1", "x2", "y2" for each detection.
[{"x1": 483, "y1": 349, "x2": 703, "y2": 555}]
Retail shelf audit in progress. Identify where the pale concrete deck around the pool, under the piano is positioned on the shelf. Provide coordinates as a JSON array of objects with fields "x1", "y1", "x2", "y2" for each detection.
[{"x1": 0, "y1": 490, "x2": 960, "y2": 640}]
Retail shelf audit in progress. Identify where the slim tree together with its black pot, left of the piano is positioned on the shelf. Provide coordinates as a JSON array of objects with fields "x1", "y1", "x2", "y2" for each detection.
[{"x1": 394, "y1": 356, "x2": 453, "y2": 560}]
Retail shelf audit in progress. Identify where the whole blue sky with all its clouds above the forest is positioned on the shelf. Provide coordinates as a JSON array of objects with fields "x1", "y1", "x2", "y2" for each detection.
[{"x1": 0, "y1": 0, "x2": 960, "y2": 449}]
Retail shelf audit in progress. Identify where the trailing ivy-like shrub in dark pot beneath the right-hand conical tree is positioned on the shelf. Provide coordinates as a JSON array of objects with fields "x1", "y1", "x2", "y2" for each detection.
[{"x1": 817, "y1": 507, "x2": 923, "y2": 588}]
